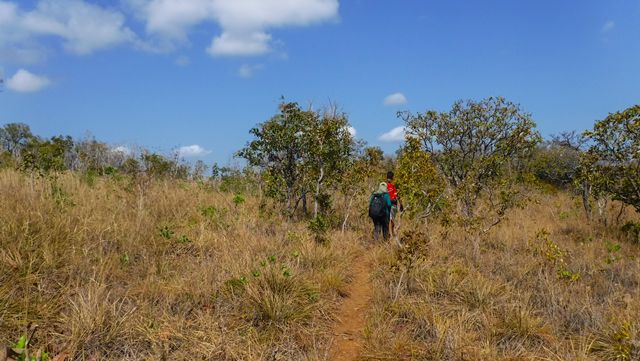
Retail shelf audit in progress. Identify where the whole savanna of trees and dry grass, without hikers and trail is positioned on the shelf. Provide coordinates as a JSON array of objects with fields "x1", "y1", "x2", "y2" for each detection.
[{"x1": 0, "y1": 97, "x2": 640, "y2": 361}]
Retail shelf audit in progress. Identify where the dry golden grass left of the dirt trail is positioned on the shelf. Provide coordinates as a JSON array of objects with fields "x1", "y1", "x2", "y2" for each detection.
[{"x1": 0, "y1": 171, "x2": 357, "y2": 360}]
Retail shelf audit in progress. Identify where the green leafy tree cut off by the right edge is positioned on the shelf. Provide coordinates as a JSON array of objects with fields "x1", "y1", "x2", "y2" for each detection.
[{"x1": 583, "y1": 105, "x2": 640, "y2": 211}]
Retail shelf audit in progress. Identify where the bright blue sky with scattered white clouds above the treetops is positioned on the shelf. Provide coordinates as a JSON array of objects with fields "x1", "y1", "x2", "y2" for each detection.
[{"x1": 0, "y1": 0, "x2": 640, "y2": 164}]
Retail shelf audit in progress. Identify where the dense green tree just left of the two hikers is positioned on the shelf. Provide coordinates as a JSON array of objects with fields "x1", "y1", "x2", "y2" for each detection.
[{"x1": 238, "y1": 103, "x2": 355, "y2": 217}]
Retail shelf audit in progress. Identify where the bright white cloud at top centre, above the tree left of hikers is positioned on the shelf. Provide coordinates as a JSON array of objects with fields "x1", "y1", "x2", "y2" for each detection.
[{"x1": 126, "y1": 0, "x2": 339, "y2": 56}]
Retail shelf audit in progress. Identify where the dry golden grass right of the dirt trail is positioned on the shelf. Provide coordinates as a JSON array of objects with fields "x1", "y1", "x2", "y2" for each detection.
[{"x1": 364, "y1": 190, "x2": 640, "y2": 360}]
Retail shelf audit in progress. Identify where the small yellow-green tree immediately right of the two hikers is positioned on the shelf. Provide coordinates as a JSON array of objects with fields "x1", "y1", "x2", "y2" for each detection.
[{"x1": 396, "y1": 137, "x2": 445, "y2": 218}]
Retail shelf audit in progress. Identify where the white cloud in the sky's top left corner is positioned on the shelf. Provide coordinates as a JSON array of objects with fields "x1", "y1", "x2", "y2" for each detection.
[{"x1": 0, "y1": 0, "x2": 136, "y2": 62}]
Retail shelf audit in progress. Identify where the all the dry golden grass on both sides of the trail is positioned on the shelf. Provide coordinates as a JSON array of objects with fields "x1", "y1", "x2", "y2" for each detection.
[{"x1": 0, "y1": 171, "x2": 640, "y2": 360}]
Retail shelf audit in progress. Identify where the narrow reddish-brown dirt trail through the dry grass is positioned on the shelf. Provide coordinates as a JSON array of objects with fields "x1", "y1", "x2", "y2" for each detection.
[{"x1": 329, "y1": 252, "x2": 372, "y2": 361}]
